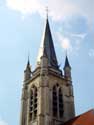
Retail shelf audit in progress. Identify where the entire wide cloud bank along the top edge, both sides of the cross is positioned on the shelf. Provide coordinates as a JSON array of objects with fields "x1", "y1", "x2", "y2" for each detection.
[{"x1": 6, "y1": 0, "x2": 94, "y2": 23}]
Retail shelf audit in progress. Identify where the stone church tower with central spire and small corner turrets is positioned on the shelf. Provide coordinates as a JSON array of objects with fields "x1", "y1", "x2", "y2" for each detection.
[{"x1": 20, "y1": 18, "x2": 75, "y2": 125}]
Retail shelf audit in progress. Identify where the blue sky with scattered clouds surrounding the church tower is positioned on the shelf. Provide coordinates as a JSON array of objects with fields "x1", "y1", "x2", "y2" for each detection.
[{"x1": 0, "y1": 0, "x2": 94, "y2": 125}]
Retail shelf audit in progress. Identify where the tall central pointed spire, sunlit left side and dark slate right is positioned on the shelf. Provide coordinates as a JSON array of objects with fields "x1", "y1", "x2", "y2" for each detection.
[{"x1": 37, "y1": 15, "x2": 59, "y2": 69}]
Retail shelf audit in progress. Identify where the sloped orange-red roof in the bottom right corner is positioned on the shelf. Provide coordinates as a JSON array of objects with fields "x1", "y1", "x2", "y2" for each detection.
[{"x1": 63, "y1": 109, "x2": 94, "y2": 125}]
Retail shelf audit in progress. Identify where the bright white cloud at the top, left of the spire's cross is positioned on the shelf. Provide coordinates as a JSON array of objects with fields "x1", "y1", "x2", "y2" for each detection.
[{"x1": 6, "y1": 0, "x2": 44, "y2": 14}]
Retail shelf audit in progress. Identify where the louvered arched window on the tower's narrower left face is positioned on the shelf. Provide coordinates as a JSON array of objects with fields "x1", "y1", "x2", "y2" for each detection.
[{"x1": 29, "y1": 86, "x2": 37, "y2": 120}]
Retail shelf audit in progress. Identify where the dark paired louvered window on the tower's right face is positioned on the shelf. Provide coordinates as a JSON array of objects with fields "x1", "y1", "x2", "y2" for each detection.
[{"x1": 52, "y1": 85, "x2": 63, "y2": 118}]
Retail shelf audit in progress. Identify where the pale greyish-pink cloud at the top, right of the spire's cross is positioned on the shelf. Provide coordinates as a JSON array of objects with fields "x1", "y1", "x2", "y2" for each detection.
[{"x1": 48, "y1": 0, "x2": 94, "y2": 23}]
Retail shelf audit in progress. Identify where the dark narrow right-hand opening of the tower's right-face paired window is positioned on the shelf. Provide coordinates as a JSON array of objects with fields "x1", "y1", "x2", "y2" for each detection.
[{"x1": 59, "y1": 88, "x2": 63, "y2": 118}]
